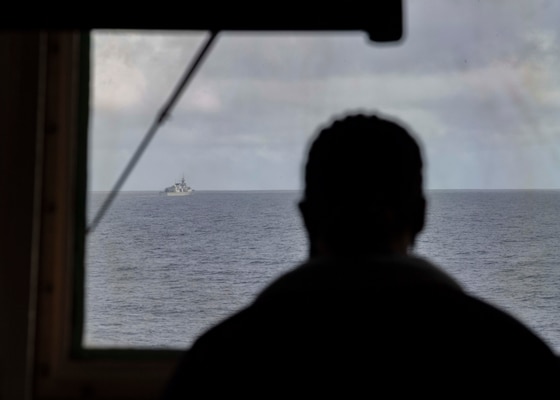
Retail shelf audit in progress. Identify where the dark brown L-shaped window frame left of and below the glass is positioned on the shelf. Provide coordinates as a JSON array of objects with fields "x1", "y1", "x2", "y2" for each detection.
[{"x1": 33, "y1": 31, "x2": 180, "y2": 399}]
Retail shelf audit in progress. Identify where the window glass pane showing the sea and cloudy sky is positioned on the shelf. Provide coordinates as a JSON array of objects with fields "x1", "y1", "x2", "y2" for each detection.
[{"x1": 84, "y1": 0, "x2": 560, "y2": 349}]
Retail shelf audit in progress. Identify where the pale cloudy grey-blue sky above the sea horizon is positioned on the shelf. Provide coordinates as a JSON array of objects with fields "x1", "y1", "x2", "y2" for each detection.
[{"x1": 88, "y1": 0, "x2": 560, "y2": 191}]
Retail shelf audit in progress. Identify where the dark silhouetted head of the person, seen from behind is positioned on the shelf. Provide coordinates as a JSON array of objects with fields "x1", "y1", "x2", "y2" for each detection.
[{"x1": 299, "y1": 114, "x2": 426, "y2": 257}]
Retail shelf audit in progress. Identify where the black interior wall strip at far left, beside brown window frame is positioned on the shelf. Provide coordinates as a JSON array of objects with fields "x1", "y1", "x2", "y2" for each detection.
[{"x1": 0, "y1": 31, "x2": 41, "y2": 399}]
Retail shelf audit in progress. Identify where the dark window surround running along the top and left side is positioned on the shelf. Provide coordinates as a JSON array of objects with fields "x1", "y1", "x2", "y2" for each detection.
[{"x1": 0, "y1": 4, "x2": 402, "y2": 399}]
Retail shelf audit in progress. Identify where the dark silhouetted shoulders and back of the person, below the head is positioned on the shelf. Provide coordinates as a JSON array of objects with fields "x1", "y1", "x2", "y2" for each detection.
[{"x1": 162, "y1": 255, "x2": 560, "y2": 394}]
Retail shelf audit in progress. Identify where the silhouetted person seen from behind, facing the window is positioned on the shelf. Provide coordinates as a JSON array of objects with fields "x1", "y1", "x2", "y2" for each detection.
[{"x1": 162, "y1": 114, "x2": 560, "y2": 399}]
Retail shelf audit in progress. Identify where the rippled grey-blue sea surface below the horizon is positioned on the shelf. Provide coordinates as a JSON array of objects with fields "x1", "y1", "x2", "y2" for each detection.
[{"x1": 84, "y1": 191, "x2": 560, "y2": 353}]
